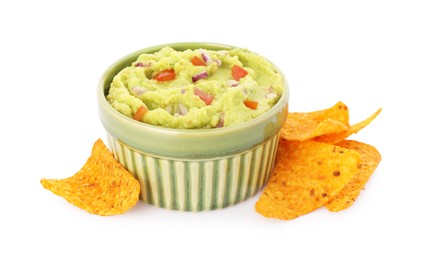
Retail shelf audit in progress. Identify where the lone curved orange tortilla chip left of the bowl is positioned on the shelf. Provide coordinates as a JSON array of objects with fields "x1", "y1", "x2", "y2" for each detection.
[{"x1": 40, "y1": 139, "x2": 140, "y2": 216}]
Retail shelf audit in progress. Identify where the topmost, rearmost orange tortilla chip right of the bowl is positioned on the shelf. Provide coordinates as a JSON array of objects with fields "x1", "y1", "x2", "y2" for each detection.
[{"x1": 281, "y1": 102, "x2": 349, "y2": 141}]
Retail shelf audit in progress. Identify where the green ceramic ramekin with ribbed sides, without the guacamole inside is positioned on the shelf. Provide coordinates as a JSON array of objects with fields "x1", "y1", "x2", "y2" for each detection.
[{"x1": 97, "y1": 42, "x2": 289, "y2": 211}]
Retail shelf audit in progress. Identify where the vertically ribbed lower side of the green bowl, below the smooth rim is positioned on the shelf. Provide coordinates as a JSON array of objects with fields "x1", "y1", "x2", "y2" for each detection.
[{"x1": 108, "y1": 134, "x2": 279, "y2": 211}]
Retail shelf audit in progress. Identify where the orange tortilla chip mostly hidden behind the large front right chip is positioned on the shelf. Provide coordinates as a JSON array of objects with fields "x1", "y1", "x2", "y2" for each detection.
[{"x1": 325, "y1": 140, "x2": 381, "y2": 212}]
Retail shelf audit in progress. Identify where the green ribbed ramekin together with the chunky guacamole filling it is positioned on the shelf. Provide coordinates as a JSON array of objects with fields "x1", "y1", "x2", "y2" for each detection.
[{"x1": 97, "y1": 42, "x2": 289, "y2": 211}]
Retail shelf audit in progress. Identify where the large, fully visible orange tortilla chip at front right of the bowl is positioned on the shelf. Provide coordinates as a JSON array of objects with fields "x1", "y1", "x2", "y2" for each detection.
[{"x1": 255, "y1": 139, "x2": 361, "y2": 220}]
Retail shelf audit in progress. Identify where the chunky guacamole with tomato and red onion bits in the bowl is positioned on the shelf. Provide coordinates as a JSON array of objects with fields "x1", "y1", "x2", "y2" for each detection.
[{"x1": 107, "y1": 47, "x2": 284, "y2": 129}]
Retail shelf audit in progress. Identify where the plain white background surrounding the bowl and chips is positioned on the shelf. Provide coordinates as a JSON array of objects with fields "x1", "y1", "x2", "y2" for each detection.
[{"x1": 0, "y1": 0, "x2": 430, "y2": 259}]
